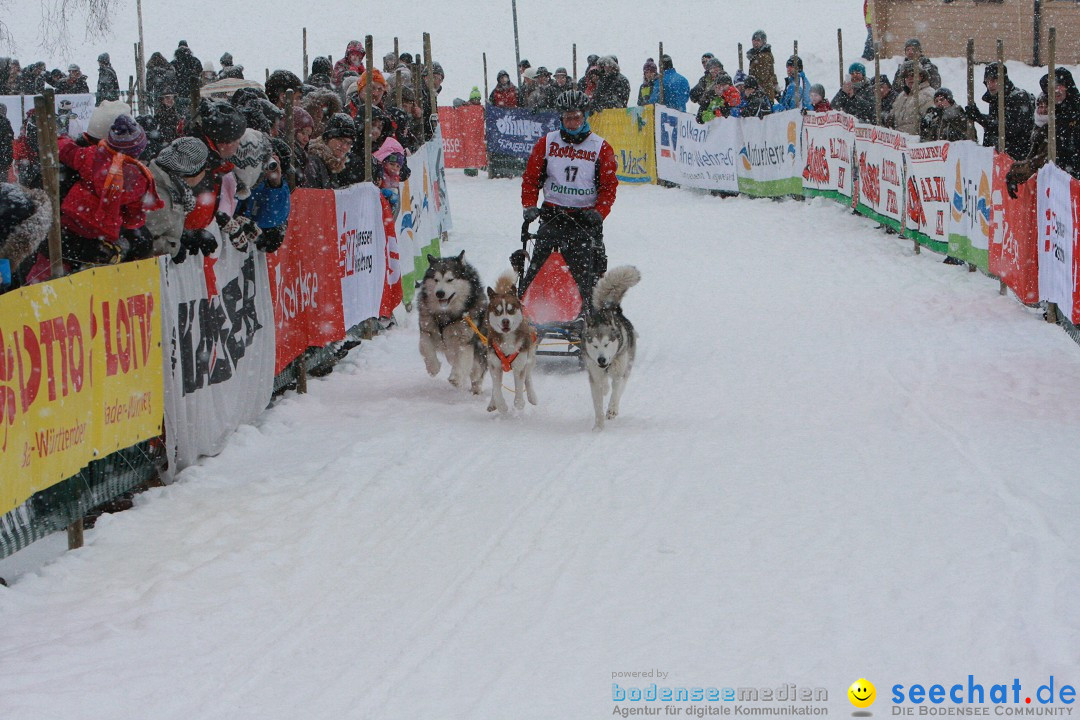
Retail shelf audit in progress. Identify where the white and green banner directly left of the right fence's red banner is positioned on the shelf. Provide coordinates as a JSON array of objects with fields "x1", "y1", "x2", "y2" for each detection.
[{"x1": 948, "y1": 140, "x2": 994, "y2": 270}]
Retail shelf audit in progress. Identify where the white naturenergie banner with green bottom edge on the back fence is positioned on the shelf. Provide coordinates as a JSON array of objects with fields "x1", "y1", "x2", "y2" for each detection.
[{"x1": 738, "y1": 110, "x2": 806, "y2": 198}]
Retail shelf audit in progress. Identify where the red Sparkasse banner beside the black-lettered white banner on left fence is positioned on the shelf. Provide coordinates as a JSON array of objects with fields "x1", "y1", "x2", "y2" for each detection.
[{"x1": 267, "y1": 189, "x2": 345, "y2": 373}]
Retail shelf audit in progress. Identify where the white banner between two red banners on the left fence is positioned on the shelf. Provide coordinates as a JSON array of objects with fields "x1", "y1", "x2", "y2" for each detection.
[{"x1": 334, "y1": 184, "x2": 390, "y2": 328}]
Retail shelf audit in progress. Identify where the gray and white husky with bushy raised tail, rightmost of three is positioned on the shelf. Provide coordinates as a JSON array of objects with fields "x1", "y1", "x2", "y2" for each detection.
[{"x1": 581, "y1": 266, "x2": 642, "y2": 431}]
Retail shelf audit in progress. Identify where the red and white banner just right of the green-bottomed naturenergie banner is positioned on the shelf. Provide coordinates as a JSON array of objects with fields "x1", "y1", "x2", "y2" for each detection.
[{"x1": 802, "y1": 111, "x2": 855, "y2": 202}]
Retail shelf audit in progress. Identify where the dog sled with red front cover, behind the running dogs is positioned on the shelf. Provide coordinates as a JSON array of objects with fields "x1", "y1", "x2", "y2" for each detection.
[{"x1": 511, "y1": 213, "x2": 598, "y2": 362}]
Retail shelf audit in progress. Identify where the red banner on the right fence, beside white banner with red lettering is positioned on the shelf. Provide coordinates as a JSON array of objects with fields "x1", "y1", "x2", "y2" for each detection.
[{"x1": 988, "y1": 153, "x2": 1039, "y2": 304}]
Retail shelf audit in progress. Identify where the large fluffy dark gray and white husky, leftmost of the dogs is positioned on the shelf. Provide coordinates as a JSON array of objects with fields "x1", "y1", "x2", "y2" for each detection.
[{"x1": 417, "y1": 250, "x2": 487, "y2": 395}]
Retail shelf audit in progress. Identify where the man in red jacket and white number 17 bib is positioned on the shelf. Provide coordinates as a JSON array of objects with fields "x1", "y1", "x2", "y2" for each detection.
[{"x1": 521, "y1": 90, "x2": 619, "y2": 308}]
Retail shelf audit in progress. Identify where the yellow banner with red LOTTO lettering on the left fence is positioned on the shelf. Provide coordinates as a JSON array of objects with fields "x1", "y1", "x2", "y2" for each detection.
[{"x1": 0, "y1": 260, "x2": 164, "y2": 515}]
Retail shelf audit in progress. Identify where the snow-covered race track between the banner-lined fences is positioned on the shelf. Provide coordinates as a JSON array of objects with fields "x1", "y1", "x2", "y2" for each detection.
[{"x1": 0, "y1": 173, "x2": 1080, "y2": 720}]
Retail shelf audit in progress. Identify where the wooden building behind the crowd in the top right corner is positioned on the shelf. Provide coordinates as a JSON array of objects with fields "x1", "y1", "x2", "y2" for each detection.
[{"x1": 869, "y1": 0, "x2": 1080, "y2": 65}]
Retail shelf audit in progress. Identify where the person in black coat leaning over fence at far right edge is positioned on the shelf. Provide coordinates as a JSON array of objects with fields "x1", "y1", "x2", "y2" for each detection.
[{"x1": 1005, "y1": 67, "x2": 1080, "y2": 198}]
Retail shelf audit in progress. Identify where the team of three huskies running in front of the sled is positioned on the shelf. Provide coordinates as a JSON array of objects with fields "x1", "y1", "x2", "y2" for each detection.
[{"x1": 417, "y1": 252, "x2": 642, "y2": 430}]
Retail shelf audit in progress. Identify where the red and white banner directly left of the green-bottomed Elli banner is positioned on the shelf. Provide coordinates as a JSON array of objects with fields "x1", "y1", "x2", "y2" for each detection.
[{"x1": 906, "y1": 141, "x2": 955, "y2": 253}]
